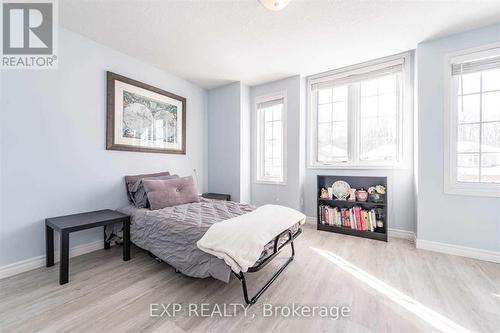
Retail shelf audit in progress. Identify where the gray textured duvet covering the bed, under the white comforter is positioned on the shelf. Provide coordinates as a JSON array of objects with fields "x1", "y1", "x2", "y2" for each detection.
[{"x1": 115, "y1": 198, "x2": 298, "y2": 282}]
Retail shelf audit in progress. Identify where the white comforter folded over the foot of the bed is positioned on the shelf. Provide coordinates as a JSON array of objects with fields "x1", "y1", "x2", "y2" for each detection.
[{"x1": 196, "y1": 205, "x2": 306, "y2": 273}]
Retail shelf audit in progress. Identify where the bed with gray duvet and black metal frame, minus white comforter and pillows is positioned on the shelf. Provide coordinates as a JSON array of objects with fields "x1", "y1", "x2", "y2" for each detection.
[{"x1": 106, "y1": 174, "x2": 302, "y2": 304}]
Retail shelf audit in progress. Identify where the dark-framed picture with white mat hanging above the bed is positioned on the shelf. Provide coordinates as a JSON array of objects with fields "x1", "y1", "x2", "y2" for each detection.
[{"x1": 106, "y1": 72, "x2": 186, "y2": 154}]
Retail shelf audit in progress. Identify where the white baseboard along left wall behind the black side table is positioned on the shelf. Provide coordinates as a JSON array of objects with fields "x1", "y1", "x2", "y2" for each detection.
[{"x1": 0, "y1": 240, "x2": 104, "y2": 279}]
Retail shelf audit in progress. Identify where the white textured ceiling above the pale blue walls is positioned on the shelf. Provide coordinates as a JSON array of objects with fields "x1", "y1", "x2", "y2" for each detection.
[{"x1": 59, "y1": 0, "x2": 500, "y2": 88}]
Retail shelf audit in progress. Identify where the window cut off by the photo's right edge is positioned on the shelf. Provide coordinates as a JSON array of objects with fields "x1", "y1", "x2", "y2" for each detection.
[{"x1": 445, "y1": 42, "x2": 500, "y2": 196}]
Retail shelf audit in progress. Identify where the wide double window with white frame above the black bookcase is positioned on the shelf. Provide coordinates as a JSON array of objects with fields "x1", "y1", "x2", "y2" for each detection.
[{"x1": 308, "y1": 54, "x2": 410, "y2": 168}]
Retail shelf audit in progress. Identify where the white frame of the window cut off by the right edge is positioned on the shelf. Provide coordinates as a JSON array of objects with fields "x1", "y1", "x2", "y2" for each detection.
[{"x1": 444, "y1": 42, "x2": 500, "y2": 197}]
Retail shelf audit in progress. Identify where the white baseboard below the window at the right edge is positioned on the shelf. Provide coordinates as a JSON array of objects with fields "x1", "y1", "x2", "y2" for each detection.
[{"x1": 416, "y1": 239, "x2": 500, "y2": 263}]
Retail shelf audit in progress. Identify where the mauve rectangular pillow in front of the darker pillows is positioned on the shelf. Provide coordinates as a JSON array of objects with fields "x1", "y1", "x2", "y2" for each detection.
[{"x1": 142, "y1": 176, "x2": 200, "y2": 210}]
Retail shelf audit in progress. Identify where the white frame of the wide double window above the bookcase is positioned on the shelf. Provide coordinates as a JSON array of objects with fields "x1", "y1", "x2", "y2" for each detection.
[{"x1": 306, "y1": 51, "x2": 413, "y2": 169}]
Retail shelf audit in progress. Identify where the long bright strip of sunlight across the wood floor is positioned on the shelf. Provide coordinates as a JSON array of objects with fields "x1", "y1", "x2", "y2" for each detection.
[{"x1": 311, "y1": 247, "x2": 470, "y2": 333}]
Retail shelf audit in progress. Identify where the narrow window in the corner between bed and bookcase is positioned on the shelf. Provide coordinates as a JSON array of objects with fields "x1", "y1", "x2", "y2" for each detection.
[{"x1": 257, "y1": 93, "x2": 286, "y2": 184}]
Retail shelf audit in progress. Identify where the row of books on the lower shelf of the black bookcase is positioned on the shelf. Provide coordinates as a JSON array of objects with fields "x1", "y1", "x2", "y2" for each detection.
[{"x1": 319, "y1": 205, "x2": 384, "y2": 231}]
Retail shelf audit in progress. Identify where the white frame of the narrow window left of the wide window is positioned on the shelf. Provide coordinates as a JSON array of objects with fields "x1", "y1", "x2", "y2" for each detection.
[{"x1": 255, "y1": 91, "x2": 287, "y2": 185}]
